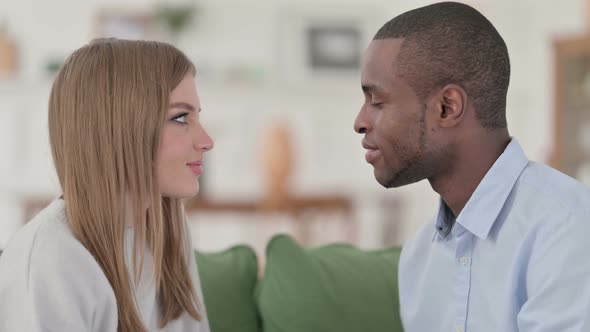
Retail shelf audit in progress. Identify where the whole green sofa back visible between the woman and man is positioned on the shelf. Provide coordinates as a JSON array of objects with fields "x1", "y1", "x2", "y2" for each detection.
[{"x1": 196, "y1": 235, "x2": 403, "y2": 332}]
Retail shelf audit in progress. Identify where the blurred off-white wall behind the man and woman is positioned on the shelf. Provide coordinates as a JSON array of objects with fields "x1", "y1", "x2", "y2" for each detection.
[{"x1": 0, "y1": 0, "x2": 585, "y2": 247}]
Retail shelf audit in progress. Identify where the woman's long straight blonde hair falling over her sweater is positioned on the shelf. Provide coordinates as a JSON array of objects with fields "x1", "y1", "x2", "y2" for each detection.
[{"x1": 49, "y1": 39, "x2": 201, "y2": 332}]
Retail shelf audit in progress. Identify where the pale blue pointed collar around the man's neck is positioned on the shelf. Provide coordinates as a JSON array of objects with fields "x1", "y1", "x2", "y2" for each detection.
[{"x1": 433, "y1": 138, "x2": 529, "y2": 240}]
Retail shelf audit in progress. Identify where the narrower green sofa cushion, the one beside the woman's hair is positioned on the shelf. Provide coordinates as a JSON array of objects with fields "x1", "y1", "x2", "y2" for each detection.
[{"x1": 196, "y1": 245, "x2": 260, "y2": 332}]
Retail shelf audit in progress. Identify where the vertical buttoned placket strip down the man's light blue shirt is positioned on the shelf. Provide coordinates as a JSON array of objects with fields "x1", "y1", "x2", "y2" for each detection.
[{"x1": 453, "y1": 232, "x2": 473, "y2": 332}]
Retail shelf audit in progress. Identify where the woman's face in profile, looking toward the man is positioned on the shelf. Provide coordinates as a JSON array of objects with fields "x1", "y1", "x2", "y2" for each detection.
[{"x1": 158, "y1": 74, "x2": 213, "y2": 198}]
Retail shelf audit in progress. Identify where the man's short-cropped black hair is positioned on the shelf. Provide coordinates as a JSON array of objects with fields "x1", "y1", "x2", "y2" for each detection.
[{"x1": 373, "y1": 2, "x2": 510, "y2": 129}]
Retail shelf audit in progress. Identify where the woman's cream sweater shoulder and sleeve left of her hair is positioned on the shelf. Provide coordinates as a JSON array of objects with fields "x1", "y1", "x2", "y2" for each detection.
[{"x1": 0, "y1": 200, "x2": 117, "y2": 330}]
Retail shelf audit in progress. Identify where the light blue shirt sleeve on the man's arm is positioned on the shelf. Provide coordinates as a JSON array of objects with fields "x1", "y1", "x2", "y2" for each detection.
[{"x1": 517, "y1": 211, "x2": 590, "y2": 332}]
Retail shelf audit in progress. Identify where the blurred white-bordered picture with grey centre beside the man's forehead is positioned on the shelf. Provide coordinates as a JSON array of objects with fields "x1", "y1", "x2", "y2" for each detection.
[{"x1": 276, "y1": 5, "x2": 385, "y2": 84}]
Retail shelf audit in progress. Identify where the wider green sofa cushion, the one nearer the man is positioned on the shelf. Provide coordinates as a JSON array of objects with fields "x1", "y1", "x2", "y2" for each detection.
[{"x1": 256, "y1": 235, "x2": 403, "y2": 332}]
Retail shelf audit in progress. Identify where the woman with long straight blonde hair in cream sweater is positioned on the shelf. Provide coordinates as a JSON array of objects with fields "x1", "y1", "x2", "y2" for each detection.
[{"x1": 0, "y1": 39, "x2": 213, "y2": 332}]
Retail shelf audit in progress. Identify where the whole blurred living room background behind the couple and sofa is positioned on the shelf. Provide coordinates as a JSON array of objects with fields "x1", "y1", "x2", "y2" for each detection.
[{"x1": 0, "y1": 0, "x2": 590, "y2": 257}]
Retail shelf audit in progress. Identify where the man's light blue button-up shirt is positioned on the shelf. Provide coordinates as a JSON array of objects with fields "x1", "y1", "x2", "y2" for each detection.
[{"x1": 399, "y1": 139, "x2": 590, "y2": 332}]
